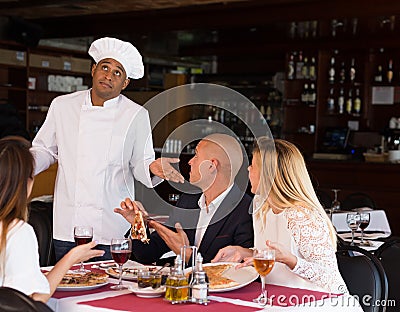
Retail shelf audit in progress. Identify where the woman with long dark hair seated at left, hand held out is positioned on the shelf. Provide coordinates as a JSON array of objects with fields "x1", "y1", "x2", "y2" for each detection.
[{"x1": 0, "y1": 137, "x2": 104, "y2": 302}]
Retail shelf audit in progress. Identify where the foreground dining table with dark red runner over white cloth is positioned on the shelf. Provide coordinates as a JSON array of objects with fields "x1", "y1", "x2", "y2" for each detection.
[{"x1": 42, "y1": 262, "x2": 362, "y2": 312}]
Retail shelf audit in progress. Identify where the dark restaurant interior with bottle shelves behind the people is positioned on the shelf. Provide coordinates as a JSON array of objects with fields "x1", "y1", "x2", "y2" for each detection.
[{"x1": 0, "y1": 0, "x2": 400, "y2": 235}]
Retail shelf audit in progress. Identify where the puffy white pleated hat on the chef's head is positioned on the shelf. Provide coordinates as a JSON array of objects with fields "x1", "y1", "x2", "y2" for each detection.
[{"x1": 88, "y1": 37, "x2": 144, "y2": 79}]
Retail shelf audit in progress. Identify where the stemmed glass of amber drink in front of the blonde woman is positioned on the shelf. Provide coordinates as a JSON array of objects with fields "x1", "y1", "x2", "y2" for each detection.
[{"x1": 253, "y1": 248, "x2": 275, "y2": 306}]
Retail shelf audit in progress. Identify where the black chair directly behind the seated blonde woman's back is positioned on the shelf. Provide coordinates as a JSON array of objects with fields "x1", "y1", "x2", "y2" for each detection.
[{"x1": 336, "y1": 246, "x2": 388, "y2": 312}]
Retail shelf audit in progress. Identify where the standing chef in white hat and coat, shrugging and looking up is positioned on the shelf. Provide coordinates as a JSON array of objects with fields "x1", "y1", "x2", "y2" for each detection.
[{"x1": 31, "y1": 37, "x2": 183, "y2": 260}]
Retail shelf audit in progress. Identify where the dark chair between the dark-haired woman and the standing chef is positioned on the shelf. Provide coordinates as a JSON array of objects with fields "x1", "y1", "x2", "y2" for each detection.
[{"x1": 28, "y1": 201, "x2": 55, "y2": 266}]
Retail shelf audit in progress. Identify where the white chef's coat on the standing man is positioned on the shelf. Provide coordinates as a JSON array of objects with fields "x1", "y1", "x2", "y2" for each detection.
[{"x1": 31, "y1": 90, "x2": 154, "y2": 244}]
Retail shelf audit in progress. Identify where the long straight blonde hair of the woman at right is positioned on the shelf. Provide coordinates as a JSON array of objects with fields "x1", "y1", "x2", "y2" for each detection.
[{"x1": 253, "y1": 137, "x2": 337, "y2": 248}]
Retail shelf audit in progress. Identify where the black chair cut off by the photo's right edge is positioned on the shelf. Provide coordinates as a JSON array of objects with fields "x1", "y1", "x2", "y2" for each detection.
[{"x1": 375, "y1": 237, "x2": 400, "y2": 312}]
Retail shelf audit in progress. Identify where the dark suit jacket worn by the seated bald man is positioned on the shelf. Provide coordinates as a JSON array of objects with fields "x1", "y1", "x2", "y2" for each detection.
[{"x1": 132, "y1": 185, "x2": 254, "y2": 264}]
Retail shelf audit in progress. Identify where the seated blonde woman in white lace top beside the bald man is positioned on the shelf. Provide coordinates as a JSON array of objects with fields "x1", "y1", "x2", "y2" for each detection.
[{"x1": 212, "y1": 137, "x2": 348, "y2": 294}]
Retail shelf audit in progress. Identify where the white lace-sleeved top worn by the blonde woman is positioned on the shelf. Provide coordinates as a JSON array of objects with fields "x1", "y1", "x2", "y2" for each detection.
[{"x1": 253, "y1": 206, "x2": 348, "y2": 294}]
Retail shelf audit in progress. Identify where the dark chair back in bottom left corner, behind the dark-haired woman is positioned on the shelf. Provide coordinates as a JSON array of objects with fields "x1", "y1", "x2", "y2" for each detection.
[{"x1": 0, "y1": 287, "x2": 53, "y2": 312}]
